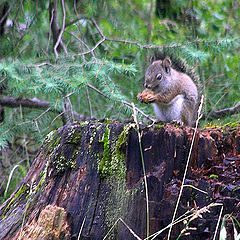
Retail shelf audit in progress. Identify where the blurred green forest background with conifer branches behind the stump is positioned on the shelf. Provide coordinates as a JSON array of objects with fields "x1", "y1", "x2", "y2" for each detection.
[{"x1": 0, "y1": 0, "x2": 240, "y2": 202}]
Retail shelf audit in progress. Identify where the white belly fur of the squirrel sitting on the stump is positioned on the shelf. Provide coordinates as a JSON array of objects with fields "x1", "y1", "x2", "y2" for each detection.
[{"x1": 153, "y1": 94, "x2": 184, "y2": 122}]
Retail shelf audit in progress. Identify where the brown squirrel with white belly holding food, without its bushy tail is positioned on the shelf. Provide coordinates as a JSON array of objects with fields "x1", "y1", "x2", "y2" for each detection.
[{"x1": 138, "y1": 54, "x2": 198, "y2": 126}]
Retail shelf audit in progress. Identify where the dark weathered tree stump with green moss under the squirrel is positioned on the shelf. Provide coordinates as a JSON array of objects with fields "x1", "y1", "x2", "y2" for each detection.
[{"x1": 0, "y1": 121, "x2": 240, "y2": 240}]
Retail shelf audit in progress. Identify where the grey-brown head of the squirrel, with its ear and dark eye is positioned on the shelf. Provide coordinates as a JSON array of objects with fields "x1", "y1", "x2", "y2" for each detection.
[{"x1": 144, "y1": 57, "x2": 172, "y2": 92}]
